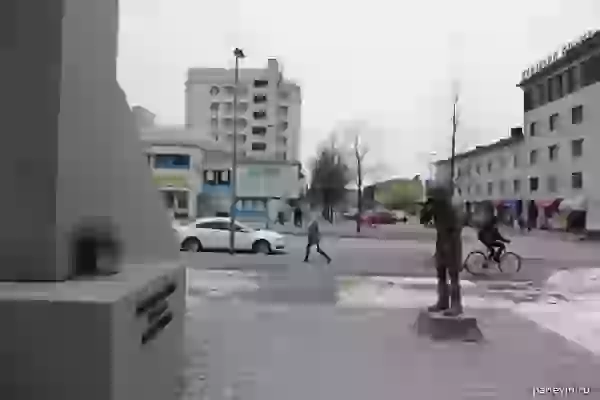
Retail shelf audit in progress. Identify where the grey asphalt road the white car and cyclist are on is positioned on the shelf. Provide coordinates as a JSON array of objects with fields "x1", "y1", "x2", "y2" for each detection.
[{"x1": 182, "y1": 227, "x2": 600, "y2": 286}]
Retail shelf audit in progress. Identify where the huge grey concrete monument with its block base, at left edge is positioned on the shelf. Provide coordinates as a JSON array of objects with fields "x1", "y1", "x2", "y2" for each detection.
[{"x1": 0, "y1": 0, "x2": 185, "y2": 400}]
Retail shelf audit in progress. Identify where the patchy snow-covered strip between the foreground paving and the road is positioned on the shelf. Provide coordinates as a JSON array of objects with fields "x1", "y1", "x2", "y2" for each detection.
[{"x1": 187, "y1": 270, "x2": 600, "y2": 355}]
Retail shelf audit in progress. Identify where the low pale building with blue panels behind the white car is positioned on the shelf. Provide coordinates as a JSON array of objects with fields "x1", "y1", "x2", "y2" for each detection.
[{"x1": 141, "y1": 127, "x2": 304, "y2": 220}]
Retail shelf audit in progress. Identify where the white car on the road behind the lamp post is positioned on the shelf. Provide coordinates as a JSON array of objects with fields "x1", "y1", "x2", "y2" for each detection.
[{"x1": 173, "y1": 217, "x2": 285, "y2": 254}]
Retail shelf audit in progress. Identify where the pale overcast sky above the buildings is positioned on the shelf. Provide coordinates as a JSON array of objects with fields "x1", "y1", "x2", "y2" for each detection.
[{"x1": 119, "y1": 0, "x2": 600, "y2": 176}]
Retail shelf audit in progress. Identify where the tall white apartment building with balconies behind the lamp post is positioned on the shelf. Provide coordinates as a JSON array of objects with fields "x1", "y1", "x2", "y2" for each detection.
[{"x1": 186, "y1": 59, "x2": 302, "y2": 161}]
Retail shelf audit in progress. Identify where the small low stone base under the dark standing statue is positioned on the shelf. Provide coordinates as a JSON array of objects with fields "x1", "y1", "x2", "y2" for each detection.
[{"x1": 414, "y1": 310, "x2": 483, "y2": 342}]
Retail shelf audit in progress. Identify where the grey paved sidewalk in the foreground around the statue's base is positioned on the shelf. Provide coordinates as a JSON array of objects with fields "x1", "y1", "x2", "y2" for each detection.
[{"x1": 182, "y1": 292, "x2": 600, "y2": 400}]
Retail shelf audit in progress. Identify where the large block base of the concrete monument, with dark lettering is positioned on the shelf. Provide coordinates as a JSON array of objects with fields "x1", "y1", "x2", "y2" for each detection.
[{"x1": 0, "y1": 264, "x2": 186, "y2": 400}]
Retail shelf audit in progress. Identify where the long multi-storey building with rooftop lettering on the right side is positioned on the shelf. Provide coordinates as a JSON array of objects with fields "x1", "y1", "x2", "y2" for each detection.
[{"x1": 436, "y1": 31, "x2": 600, "y2": 232}]
